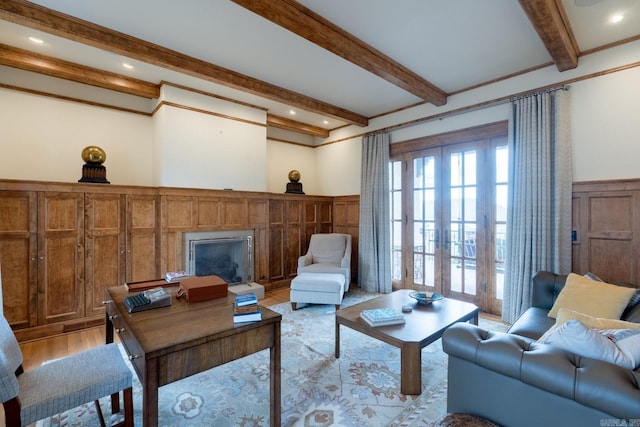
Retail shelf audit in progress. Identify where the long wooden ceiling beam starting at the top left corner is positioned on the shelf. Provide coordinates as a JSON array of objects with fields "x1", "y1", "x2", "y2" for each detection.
[{"x1": 0, "y1": 0, "x2": 369, "y2": 127}]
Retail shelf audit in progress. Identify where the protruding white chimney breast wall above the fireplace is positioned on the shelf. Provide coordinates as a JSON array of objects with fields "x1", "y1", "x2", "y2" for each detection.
[{"x1": 153, "y1": 87, "x2": 267, "y2": 191}]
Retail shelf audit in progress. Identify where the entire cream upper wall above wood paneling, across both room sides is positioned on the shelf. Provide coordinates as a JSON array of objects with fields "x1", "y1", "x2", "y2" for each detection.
[{"x1": 0, "y1": 41, "x2": 640, "y2": 196}]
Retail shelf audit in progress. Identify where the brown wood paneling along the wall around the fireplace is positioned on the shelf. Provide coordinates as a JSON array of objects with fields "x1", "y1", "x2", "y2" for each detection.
[{"x1": 0, "y1": 180, "x2": 359, "y2": 341}]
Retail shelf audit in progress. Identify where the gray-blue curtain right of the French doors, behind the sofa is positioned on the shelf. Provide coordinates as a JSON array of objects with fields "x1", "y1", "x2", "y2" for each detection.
[{"x1": 502, "y1": 88, "x2": 573, "y2": 322}]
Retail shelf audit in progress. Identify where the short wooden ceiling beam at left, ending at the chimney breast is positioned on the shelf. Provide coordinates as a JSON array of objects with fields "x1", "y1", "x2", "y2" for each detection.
[{"x1": 0, "y1": 44, "x2": 160, "y2": 99}]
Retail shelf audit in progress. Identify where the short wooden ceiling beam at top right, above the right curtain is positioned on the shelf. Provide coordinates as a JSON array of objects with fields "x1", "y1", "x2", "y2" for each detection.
[{"x1": 519, "y1": 0, "x2": 579, "y2": 71}]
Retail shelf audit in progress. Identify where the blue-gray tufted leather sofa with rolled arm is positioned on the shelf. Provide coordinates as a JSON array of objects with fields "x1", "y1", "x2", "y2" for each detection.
[{"x1": 442, "y1": 272, "x2": 640, "y2": 427}]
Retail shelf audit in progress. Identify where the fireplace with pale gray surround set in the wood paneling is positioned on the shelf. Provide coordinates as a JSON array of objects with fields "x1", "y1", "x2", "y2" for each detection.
[{"x1": 183, "y1": 230, "x2": 253, "y2": 285}]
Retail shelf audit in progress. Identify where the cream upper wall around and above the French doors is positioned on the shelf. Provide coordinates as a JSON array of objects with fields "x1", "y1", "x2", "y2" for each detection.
[{"x1": 316, "y1": 41, "x2": 640, "y2": 195}]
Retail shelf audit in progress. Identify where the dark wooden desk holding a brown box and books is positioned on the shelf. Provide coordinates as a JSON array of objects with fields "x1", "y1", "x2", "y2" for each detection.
[{"x1": 105, "y1": 286, "x2": 282, "y2": 427}]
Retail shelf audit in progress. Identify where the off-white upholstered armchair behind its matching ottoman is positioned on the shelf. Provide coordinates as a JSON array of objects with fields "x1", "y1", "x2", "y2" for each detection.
[{"x1": 298, "y1": 233, "x2": 351, "y2": 292}]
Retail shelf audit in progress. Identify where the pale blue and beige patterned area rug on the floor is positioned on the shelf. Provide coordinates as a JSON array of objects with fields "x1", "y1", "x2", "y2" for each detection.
[{"x1": 38, "y1": 288, "x2": 502, "y2": 427}]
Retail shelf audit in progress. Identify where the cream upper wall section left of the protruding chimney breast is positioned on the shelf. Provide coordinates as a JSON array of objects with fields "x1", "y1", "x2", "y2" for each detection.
[{"x1": 0, "y1": 88, "x2": 152, "y2": 185}]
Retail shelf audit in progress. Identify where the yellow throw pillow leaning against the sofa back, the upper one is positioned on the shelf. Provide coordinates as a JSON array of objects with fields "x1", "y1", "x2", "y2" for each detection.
[{"x1": 549, "y1": 273, "x2": 635, "y2": 319}]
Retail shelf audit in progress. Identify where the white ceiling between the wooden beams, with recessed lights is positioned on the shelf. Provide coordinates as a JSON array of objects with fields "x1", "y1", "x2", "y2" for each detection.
[{"x1": 0, "y1": 0, "x2": 640, "y2": 136}]
